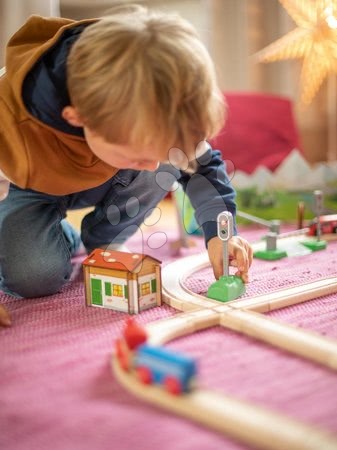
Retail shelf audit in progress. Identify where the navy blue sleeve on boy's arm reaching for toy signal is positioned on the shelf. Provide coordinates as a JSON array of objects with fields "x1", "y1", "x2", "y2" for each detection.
[{"x1": 179, "y1": 148, "x2": 237, "y2": 245}]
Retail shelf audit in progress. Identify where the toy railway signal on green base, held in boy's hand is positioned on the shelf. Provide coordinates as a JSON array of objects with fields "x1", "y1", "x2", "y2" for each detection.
[{"x1": 207, "y1": 211, "x2": 245, "y2": 302}]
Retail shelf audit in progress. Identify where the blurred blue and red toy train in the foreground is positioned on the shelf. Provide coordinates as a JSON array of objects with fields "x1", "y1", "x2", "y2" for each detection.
[{"x1": 115, "y1": 318, "x2": 197, "y2": 395}]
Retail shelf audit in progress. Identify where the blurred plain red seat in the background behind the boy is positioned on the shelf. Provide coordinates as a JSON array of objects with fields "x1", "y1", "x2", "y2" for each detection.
[{"x1": 211, "y1": 92, "x2": 301, "y2": 173}]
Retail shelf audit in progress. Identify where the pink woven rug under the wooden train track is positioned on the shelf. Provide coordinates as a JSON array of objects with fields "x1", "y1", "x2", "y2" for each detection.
[{"x1": 0, "y1": 230, "x2": 337, "y2": 450}]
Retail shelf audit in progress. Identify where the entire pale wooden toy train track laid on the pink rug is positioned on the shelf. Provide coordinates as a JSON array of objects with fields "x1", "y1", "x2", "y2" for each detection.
[{"x1": 112, "y1": 253, "x2": 337, "y2": 450}]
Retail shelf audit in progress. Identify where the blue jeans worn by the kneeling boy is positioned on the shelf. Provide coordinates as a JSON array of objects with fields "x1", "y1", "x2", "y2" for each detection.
[{"x1": 0, "y1": 165, "x2": 180, "y2": 297}]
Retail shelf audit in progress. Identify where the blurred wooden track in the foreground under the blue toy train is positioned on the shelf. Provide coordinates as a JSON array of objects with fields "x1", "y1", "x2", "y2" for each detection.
[{"x1": 112, "y1": 357, "x2": 337, "y2": 450}]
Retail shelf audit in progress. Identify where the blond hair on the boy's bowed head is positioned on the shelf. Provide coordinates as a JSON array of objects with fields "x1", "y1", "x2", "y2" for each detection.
[{"x1": 67, "y1": 5, "x2": 224, "y2": 164}]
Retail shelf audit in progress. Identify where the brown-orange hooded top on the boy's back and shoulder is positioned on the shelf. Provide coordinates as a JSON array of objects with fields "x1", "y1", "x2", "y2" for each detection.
[{"x1": 0, "y1": 16, "x2": 117, "y2": 195}]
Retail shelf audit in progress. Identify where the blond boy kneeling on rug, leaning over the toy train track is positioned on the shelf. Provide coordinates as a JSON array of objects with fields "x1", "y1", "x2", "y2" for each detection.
[{"x1": 0, "y1": 5, "x2": 252, "y2": 325}]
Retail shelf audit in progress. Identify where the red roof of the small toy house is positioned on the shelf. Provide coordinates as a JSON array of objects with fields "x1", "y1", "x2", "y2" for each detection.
[{"x1": 82, "y1": 248, "x2": 161, "y2": 272}]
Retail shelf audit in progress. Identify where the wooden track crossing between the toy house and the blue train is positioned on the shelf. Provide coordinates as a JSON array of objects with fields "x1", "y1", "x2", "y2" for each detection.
[{"x1": 159, "y1": 253, "x2": 337, "y2": 370}]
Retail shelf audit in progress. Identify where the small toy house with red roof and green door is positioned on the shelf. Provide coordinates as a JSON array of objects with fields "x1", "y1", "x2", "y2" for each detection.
[{"x1": 82, "y1": 248, "x2": 161, "y2": 314}]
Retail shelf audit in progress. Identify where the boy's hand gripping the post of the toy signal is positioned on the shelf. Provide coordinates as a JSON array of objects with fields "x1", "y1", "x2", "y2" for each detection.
[{"x1": 208, "y1": 236, "x2": 253, "y2": 283}]
